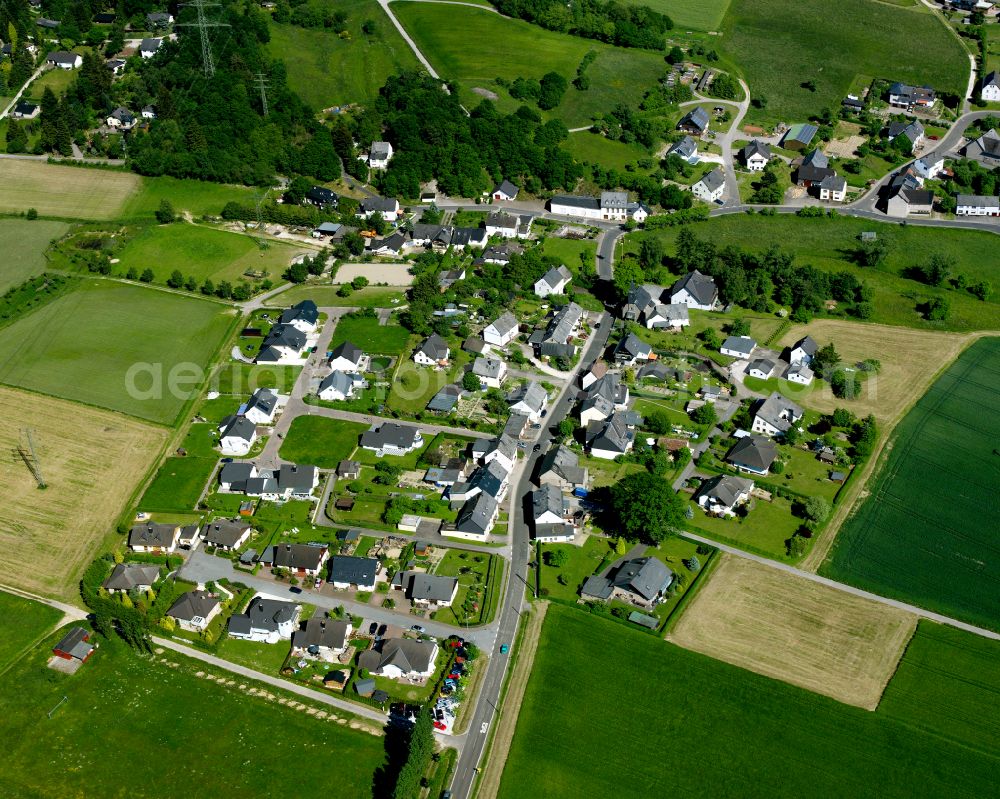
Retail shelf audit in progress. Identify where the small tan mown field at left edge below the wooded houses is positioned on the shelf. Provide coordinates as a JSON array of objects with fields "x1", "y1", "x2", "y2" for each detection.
[{"x1": 0, "y1": 158, "x2": 142, "y2": 219}]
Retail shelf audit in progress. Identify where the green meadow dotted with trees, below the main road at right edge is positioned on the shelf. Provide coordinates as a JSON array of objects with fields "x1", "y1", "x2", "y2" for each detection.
[{"x1": 627, "y1": 212, "x2": 1000, "y2": 331}]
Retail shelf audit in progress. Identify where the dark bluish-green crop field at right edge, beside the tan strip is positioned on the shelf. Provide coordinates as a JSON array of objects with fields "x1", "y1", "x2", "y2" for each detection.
[{"x1": 821, "y1": 338, "x2": 1000, "y2": 629}]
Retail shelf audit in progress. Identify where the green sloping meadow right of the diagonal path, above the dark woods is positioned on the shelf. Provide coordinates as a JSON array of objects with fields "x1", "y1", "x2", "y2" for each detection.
[{"x1": 392, "y1": 2, "x2": 667, "y2": 128}]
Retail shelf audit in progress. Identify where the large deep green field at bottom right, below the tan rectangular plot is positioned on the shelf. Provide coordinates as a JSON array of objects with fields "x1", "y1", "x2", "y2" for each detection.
[{"x1": 499, "y1": 604, "x2": 1000, "y2": 799}]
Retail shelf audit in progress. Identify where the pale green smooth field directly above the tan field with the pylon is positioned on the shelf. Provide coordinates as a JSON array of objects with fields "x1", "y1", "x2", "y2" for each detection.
[{"x1": 0, "y1": 280, "x2": 234, "y2": 424}]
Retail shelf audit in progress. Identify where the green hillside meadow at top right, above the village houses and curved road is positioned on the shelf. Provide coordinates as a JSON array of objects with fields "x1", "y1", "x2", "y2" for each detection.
[{"x1": 719, "y1": 0, "x2": 969, "y2": 124}]
